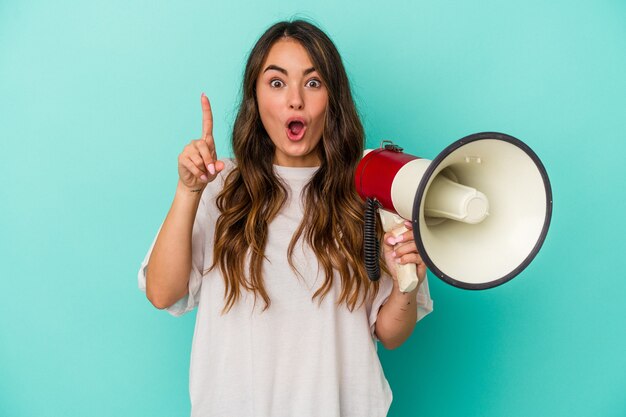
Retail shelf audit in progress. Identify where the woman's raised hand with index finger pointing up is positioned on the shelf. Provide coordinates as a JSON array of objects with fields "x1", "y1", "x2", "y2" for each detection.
[{"x1": 178, "y1": 93, "x2": 224, "y2": 191}]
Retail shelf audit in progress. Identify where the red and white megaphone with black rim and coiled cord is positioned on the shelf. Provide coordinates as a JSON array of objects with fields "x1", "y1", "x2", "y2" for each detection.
[{"x1": 355, "y1": 132, "x2": 552, "y2": 292}]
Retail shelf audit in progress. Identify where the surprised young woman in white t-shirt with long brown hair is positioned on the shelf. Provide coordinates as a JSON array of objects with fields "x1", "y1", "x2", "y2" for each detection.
[{"x1": 139, "y1": 21, "x2": 432, "y2": 417}]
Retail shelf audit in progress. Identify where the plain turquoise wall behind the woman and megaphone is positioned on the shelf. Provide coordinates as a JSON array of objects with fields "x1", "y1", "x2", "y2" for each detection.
[{"x1": 0, "y1": 0, "x2": 626, "y2": 417}]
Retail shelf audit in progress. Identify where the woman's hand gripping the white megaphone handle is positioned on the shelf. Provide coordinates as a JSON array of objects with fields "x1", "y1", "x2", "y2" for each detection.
[{"x1": 383, "y1": 221, "x2": 426, "y2": 287}]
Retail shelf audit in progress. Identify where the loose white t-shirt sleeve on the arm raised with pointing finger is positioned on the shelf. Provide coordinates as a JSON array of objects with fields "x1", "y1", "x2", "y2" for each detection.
[{"x1": 138, "y1": 195, "x2": 208, "y2": 317}]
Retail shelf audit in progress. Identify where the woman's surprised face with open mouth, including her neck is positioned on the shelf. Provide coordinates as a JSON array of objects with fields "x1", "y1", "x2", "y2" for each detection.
[{"x1": 256, "y1": 38, "x2": 328, "y2": 167}]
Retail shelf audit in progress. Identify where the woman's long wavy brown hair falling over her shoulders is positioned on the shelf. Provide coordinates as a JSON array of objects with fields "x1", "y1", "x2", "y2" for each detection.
[{"x1": 211, "y1": 20, "x2": 379, "y2": 313}]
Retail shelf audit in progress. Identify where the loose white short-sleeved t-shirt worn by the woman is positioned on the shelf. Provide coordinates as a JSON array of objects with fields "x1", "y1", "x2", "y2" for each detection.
[{"x1": 139, "y1": 161, "x2": 433, "y2": 417}]
